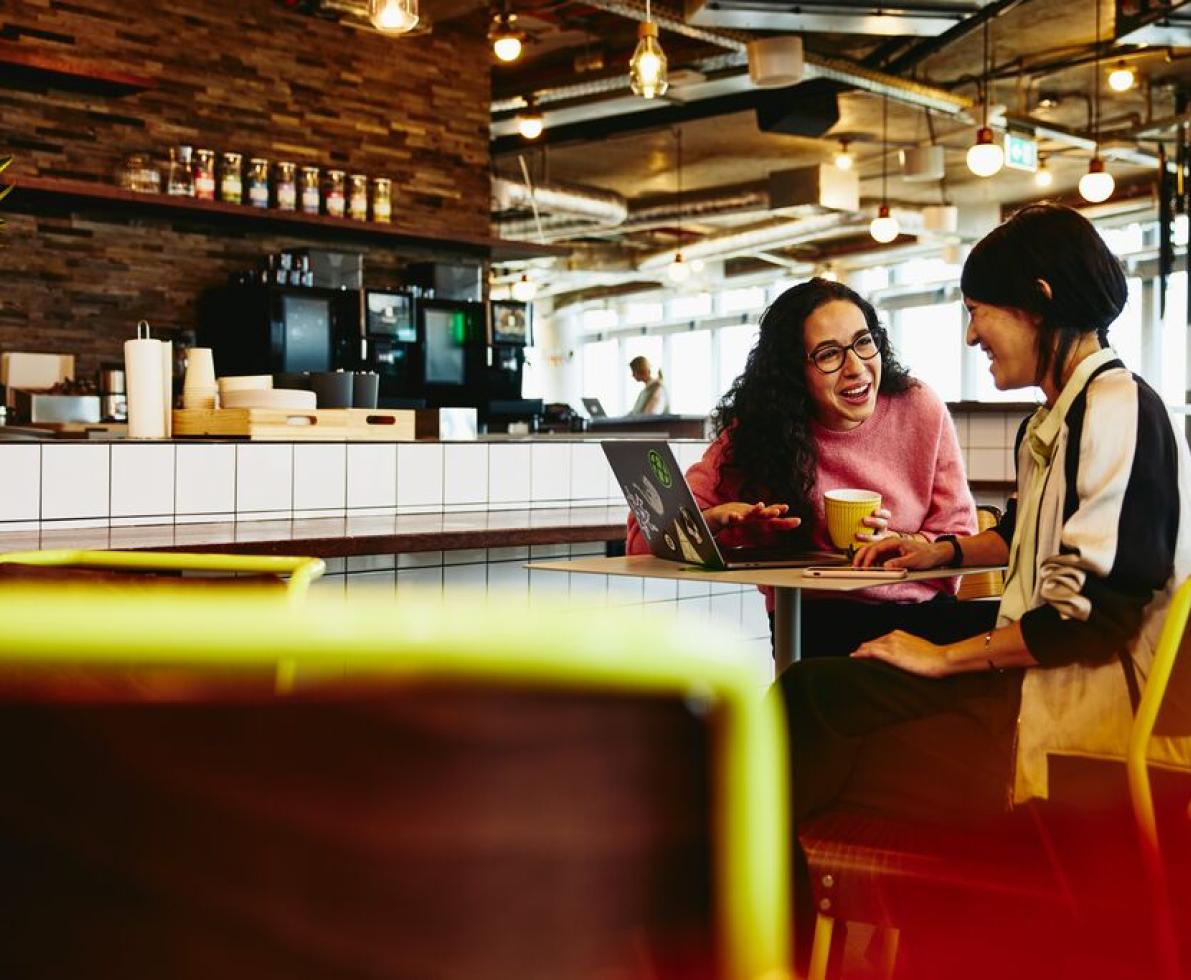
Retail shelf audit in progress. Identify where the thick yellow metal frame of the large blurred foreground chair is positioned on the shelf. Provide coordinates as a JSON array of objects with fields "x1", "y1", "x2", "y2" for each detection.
[{"x1": 0, "y1": 583, "x2": 792, "y2": 980}]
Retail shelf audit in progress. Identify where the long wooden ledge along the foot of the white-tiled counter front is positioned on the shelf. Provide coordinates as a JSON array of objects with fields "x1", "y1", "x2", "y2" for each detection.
[{"x1": 0, "y1": 506, "x2": 629, "y2": 558}]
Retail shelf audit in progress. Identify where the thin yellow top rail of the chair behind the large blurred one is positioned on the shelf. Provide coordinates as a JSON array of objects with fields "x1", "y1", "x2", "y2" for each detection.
[{"x1": 0, "y1": 549, "x2": 326, "y2": 598}]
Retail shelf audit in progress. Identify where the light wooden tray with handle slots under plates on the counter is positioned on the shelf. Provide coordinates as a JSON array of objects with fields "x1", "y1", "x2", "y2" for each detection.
[{"x1": 174, "y1": 408, "x2": 414, "y2": 442}]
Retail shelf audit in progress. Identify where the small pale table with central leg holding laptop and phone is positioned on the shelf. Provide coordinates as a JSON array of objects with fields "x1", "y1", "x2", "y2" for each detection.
[{"x1": 526, "y1": 555, "x2": 999, "y2": 673}]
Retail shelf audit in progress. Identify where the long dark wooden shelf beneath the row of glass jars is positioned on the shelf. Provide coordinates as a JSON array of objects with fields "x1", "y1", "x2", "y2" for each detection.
[{"x1": 5, "y1": 175, "x2": 568, "y2": 261}]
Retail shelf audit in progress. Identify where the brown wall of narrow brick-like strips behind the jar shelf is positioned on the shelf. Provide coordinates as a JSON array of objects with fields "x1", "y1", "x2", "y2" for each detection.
[{"x1": 0, "y1": 0, "x2": 490, "y2": 373}]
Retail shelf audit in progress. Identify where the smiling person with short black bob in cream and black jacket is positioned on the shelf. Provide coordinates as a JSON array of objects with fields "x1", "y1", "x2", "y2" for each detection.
[{"x1": 780, "y1": 205, "x2": 1191, "y2": 962}]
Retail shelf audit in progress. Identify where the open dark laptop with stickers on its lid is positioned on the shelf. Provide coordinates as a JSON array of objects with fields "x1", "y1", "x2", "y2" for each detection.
[{"x1": 605, "y1": 440, "x2": 848, "y2": 570}]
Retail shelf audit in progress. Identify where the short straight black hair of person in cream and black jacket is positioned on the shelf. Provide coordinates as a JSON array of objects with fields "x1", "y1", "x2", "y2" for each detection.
[{"x1": 960, "y1": 204, "x2": 1129, "y2": 387}]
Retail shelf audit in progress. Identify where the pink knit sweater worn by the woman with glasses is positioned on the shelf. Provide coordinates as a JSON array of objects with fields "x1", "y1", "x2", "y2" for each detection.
[{"x1": 628, "y1": 383, "x2": 975, "y2": 610}]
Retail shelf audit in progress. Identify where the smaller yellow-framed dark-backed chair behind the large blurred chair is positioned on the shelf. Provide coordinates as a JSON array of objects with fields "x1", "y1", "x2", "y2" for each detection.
[{"x1": 0, "y1": 549, "x2": 326, "y2": 598}]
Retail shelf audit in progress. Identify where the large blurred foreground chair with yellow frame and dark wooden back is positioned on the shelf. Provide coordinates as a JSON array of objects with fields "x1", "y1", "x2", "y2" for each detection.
[{"x1": 0, "y1": 587, "x2": 791, "y2": 980}]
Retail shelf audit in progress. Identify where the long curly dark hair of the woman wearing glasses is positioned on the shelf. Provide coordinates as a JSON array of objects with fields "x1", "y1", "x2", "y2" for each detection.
[{"x1": 712, "y1": 277, "x2": 918, "y2": 530}]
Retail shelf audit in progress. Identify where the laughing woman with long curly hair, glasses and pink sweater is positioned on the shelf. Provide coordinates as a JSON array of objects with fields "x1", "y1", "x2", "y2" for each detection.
[{"x1": 629, "y1": 279, "x2": 992, "y2": 656}]
